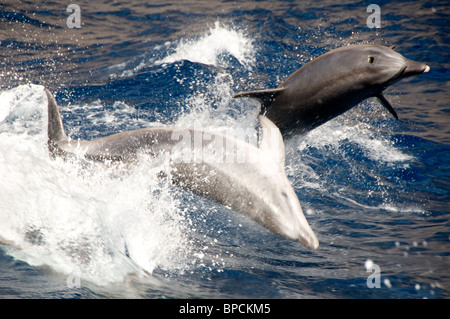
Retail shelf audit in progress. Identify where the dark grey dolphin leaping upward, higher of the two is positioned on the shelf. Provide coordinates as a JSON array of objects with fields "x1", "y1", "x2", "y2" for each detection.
[{"x1": 234, "y1": 44, "x2": 430, "y2": 137}]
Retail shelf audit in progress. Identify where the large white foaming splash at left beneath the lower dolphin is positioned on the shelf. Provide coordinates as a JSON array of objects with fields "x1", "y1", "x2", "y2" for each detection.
[{"x1": 0, "y1": 85, "x2": 192, "y2": 285}]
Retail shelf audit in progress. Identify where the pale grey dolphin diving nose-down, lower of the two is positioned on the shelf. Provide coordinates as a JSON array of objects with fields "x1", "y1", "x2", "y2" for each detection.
[{"x1": 45, "y1": 88, "x2": 319, "y2": 249}]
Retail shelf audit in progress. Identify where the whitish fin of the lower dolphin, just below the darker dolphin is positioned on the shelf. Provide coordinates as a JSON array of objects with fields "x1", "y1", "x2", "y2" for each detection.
[{"x1": 258, "y1": 114, "x2": 286, "y2": 171}]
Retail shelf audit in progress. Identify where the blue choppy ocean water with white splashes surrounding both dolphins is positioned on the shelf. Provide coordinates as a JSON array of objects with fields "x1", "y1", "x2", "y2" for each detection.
[{"x1": 0, "y1": 0, "x2": 450, "y2": 299}]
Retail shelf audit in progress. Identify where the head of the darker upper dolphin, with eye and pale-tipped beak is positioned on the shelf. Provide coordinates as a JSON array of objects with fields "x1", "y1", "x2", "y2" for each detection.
[{"x1": 342, "y1": 45, "x2": 430, "y2": 92}]
